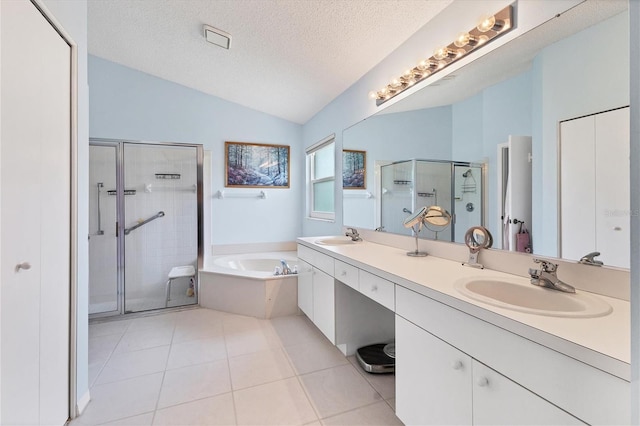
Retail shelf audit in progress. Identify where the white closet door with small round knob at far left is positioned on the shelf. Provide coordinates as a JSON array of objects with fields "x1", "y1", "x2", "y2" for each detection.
[{"x1": 0, "y1": 1, "x2": 71, "y2": 425}]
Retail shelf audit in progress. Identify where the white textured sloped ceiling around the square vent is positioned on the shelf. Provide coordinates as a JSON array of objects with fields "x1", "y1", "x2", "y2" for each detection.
[{"x1": 88, "y1": 0, "x2": 451, "y2": 124}]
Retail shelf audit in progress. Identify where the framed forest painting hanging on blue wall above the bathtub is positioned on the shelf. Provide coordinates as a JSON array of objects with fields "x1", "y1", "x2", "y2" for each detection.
[{"x1": 224, "y1": 142, "x2": 289, "y2": 188}]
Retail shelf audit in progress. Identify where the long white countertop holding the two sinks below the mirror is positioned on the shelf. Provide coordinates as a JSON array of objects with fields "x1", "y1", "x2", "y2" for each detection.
[{"x1": 298, "y1": 237, "x2": 631, "y2": 381}]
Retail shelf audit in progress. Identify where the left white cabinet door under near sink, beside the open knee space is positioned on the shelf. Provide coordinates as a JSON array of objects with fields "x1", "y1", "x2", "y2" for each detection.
[{"x1": 396, "y1": 315, "x2": 472, "y2": 425}]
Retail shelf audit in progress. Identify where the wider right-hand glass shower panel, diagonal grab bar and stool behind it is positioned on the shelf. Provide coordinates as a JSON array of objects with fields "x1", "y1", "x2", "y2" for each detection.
[{"x1": 121, "y1": 143, "x2": 201, "y2": 312}]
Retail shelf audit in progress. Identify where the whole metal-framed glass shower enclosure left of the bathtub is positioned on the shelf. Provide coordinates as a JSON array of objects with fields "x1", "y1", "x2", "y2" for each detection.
[{"x1": 89, "y1": 139, "x2": 203, "y2": 317}]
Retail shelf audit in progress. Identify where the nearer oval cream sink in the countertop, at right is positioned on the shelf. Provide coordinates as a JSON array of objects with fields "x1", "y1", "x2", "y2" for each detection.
[{"x1": 455, "y1": 278, "x2": 612, "y2": 318}]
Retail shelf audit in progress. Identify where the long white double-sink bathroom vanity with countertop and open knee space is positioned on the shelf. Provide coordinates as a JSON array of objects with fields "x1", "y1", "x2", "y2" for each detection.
[{"x1": 298, "y1": 237, "x2": 630, "y2": 425}]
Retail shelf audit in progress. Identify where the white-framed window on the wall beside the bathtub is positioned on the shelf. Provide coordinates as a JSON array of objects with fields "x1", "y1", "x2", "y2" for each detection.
[{"x1": 307, "y1": 135, "x2": 336, "y2": 220}]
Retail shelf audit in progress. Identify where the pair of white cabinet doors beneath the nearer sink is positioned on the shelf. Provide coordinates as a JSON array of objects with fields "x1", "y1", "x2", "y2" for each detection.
[{"x1": 396, "y1": 316, "x2": 584, "y2": 425}]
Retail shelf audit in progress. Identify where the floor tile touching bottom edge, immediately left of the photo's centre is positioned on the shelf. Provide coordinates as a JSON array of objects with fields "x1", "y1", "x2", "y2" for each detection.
[{"x1": 233, "y1": 377, "x2": 317, "y2": 425}]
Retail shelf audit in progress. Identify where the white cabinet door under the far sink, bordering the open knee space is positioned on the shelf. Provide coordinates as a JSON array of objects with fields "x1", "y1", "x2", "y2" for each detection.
[{"x1": 313, "y1": 268, "x2": 336, "y2": 344}]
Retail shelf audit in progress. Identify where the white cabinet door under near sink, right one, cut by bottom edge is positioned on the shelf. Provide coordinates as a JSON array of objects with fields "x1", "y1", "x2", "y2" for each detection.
[{"x1": 473, "y1": 360, "x2": 584, "y2": 425}]
